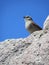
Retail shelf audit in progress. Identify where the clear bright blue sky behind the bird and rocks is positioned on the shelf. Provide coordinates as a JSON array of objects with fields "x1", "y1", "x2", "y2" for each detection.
[{"x1": 0, "y1": 0, "x2": 49, "y2": 41}]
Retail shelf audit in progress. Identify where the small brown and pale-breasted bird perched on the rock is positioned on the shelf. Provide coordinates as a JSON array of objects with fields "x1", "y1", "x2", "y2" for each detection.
[{"x1": 24, "y1": 16, "x2": 42, "y2": 33}]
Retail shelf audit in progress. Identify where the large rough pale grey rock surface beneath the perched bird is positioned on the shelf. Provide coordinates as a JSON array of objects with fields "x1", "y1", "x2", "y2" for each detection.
[{"x1": 0, "y1": 15, "x2": 49, "y2": 65}]
